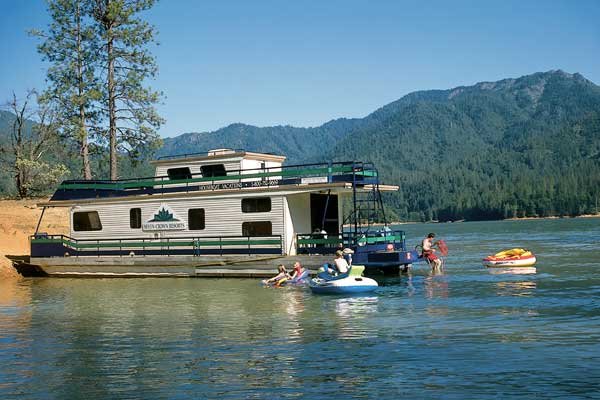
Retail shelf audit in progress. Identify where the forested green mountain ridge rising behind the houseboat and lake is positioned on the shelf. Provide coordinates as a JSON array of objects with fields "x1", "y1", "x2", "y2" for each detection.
[{"x1": 0, "y1": 70, "x2": 600, "y2": 221}]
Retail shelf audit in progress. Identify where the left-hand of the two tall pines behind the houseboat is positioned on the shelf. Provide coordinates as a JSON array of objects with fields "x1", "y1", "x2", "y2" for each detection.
[{"x1": 31, "y1": 0, "x2": 101, "y2": 179}]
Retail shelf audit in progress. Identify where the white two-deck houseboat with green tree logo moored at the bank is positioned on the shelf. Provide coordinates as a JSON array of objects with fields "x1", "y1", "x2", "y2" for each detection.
[{"x1": 23, "y1": 149, "x2": 417, "y2": 277}]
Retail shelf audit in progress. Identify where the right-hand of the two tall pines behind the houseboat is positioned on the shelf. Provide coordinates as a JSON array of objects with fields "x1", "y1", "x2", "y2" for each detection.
[{"x1": 93, "y1": 0, "x2": 163, "y2": 180}]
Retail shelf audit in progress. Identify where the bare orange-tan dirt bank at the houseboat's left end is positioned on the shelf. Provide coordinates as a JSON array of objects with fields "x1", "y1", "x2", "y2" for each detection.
[{"x1": 0, "y1": 199, "x2": 69, "y2": 279}]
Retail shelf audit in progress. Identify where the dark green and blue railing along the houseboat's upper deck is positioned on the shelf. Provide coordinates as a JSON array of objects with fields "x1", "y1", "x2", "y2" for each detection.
[{"x1": 50, "y1": 161, "x2": 378, "y2": 201}]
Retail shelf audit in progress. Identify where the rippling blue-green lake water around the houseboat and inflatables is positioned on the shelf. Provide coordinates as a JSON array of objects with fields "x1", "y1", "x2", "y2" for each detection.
[{"x1": 0, "y1": 218, "x2": 600, "y2": 399}]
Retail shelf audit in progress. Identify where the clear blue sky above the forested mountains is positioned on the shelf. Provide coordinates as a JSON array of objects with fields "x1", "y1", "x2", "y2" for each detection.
[{"x1": 0, "y1": 0, "x2": 600, "y2": 137}]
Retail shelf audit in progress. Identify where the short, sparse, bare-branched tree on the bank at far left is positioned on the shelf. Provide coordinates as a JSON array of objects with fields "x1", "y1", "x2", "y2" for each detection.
[{"x1": 0, "y1": 91, "x2": 69, "y2": 198}]
